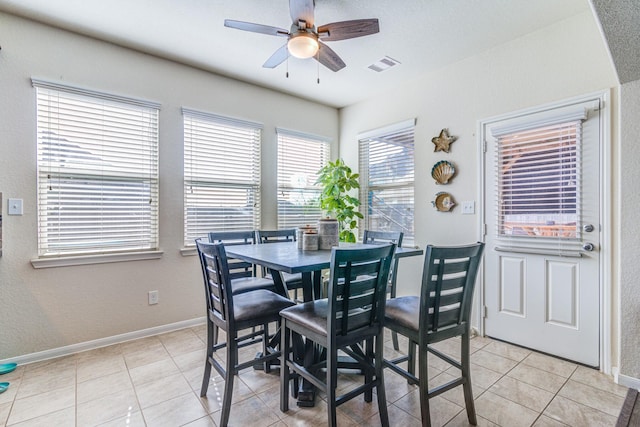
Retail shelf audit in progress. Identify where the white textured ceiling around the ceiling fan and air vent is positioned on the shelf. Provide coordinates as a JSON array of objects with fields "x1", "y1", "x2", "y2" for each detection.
[{"x1": 0, "y1": 0, "x2": 592, "y2": 107}]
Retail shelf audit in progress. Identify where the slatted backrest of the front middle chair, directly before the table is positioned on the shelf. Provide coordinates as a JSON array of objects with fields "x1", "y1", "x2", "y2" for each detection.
[{"x1": 328, "y1": 244, "x2": 395, "y2": 337}]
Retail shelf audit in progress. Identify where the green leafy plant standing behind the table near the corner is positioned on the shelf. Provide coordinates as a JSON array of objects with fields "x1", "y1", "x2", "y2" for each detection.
[{"x1": 316, "y1": 159, "x2": 364, "y2": 243}]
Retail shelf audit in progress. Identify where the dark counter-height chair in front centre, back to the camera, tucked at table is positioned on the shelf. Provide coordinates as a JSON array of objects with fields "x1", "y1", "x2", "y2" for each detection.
[{"x1": 280, "y1": 244, "x2": 395, "y2": 426}]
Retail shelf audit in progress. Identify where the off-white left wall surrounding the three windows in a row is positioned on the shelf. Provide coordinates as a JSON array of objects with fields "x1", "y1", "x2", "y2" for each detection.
[{"x1": 0, "y1": 13, "x2": 338, "y2": 360}]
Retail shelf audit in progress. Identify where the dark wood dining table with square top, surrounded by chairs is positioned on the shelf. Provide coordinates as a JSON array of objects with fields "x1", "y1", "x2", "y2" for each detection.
[{"x1": 225, "y1": 242, "x2": 424, "y2": 406}]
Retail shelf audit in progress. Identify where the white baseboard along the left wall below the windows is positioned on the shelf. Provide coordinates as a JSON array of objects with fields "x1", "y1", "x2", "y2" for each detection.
[{"x1": 0, "y1": 317, "x2": 206, "y2": 365}]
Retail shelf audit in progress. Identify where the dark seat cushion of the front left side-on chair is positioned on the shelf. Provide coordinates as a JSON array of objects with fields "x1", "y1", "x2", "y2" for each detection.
[{"x1": 233, "y1": 289, "x2": 295, "y2": 323}]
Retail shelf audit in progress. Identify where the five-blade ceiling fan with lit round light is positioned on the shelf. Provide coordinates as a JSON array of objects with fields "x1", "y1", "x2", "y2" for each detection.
[{"x1": 224, "y1": 0, "x2": 380, "y2": 71}]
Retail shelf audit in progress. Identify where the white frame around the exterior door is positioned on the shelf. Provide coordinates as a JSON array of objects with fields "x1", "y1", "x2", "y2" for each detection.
[{"x1": 474, "y1": 89, "x2": 617, "y2": 375}]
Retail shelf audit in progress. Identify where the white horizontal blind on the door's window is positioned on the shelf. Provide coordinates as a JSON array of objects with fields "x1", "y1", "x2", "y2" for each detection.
[{"x1": 496, "y1": 120, "x2": 582, "y2": 239}]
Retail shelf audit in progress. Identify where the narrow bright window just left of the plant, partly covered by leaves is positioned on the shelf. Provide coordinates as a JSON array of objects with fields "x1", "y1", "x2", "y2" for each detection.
[{"x1": 277, "y1": 129, "x2": 331, "y2": 229}]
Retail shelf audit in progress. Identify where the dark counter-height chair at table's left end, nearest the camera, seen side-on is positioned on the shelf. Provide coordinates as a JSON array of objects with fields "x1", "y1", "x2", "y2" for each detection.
[{"x1": 196, "y1": 240, "x2": 295, "y2": 426}]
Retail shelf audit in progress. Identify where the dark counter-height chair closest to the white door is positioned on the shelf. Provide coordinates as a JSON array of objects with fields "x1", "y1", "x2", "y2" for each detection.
[{"x1": 384, "y1": 242, "x2": 484, "y2": 426}]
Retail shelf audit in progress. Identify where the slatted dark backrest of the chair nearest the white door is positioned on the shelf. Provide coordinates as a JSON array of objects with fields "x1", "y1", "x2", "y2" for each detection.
[{"x1": 420, "y1": 242, "x2": 484, "y2": 334}]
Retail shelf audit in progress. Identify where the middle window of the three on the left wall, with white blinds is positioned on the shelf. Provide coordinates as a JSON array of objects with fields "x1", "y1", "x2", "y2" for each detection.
[{"x1": 182, "y1": 108, "x2": 262, "y2": 247}]
